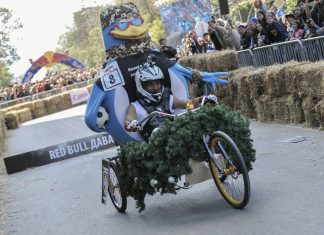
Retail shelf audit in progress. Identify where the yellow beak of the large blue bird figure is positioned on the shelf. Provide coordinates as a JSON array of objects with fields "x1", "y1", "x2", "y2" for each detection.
[{"x1": 111, "y1": 22, "x2": 148, "y2": 40}]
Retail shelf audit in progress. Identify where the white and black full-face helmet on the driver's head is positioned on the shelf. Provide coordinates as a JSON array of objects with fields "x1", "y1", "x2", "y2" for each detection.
[{"x1": 135, "y1": 63, "x2": 164, "y2": 103}]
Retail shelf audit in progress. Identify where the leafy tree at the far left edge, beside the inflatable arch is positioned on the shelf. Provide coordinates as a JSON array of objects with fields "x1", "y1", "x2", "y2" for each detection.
[{"x1": 0, "y1": 7, "x2": 22, "y2": 86}]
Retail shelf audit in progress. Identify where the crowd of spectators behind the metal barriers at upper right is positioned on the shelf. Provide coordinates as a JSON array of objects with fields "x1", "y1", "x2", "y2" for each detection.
[{"x1": 161, "y1": 0, "x2": 324, "y2": 58}]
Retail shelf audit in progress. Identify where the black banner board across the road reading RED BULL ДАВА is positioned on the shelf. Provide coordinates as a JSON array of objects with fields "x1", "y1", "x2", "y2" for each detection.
[{"x1": 4, "y1": 133, "x2": 115, "y2": 174}]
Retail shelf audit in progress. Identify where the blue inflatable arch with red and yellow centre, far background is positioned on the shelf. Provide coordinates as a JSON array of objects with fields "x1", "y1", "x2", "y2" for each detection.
[{"x1": 21, "y1": 51, "x2": 84, "y2": 83}]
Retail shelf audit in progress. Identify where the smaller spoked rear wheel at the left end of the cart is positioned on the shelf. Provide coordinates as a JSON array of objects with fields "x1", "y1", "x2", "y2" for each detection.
[{"x1": 108, "y1": 162, "x2": 127, "y2": 212}]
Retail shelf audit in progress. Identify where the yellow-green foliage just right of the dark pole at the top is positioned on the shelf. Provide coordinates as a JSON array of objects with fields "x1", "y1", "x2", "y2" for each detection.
[{"x1": 230, "y1": 1, "x2": 255, "y2": 22}]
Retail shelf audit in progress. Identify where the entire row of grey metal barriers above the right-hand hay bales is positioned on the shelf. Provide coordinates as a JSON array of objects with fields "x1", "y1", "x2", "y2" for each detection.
[{"x1": 237, "y1": 36, "x2": 324, "y2": 67}]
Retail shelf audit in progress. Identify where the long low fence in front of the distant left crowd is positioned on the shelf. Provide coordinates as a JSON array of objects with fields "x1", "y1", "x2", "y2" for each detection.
[{"x1": 0, "y1": 78, "x2": 98, "y2": 109}]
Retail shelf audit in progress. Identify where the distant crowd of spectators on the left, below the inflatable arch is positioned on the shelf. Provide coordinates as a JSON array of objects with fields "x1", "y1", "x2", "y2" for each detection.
[{"x1": 0, "y1": 68, "x2": 99, "y2": 102}]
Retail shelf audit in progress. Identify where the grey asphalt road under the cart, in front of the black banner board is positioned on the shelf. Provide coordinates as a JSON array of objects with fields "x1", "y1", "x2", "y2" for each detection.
[{"x1": 0, "y1": 105, "x2": 324, "y2": 235}]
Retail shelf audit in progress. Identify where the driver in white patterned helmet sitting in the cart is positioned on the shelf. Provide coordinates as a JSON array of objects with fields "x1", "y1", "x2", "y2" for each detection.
[{"x1": 124, "y1": 56, "x2": 199, "y2": 141}]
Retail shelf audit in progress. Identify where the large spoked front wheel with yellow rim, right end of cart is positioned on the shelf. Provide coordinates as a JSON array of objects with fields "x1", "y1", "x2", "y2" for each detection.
[{"x1": 208, "y1": 131, "x2": 250, "y2": 209}]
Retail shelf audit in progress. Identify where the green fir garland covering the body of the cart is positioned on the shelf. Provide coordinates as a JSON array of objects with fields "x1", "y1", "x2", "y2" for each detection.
[{"x1": 118, "y1": 105, "x2": 255, "y2": 212}]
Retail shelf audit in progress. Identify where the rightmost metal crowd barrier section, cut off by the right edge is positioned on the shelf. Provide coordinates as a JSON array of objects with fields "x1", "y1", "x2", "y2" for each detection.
[{"x1": 302, "y1": 36, "x2": 324, "y2": 62}]
